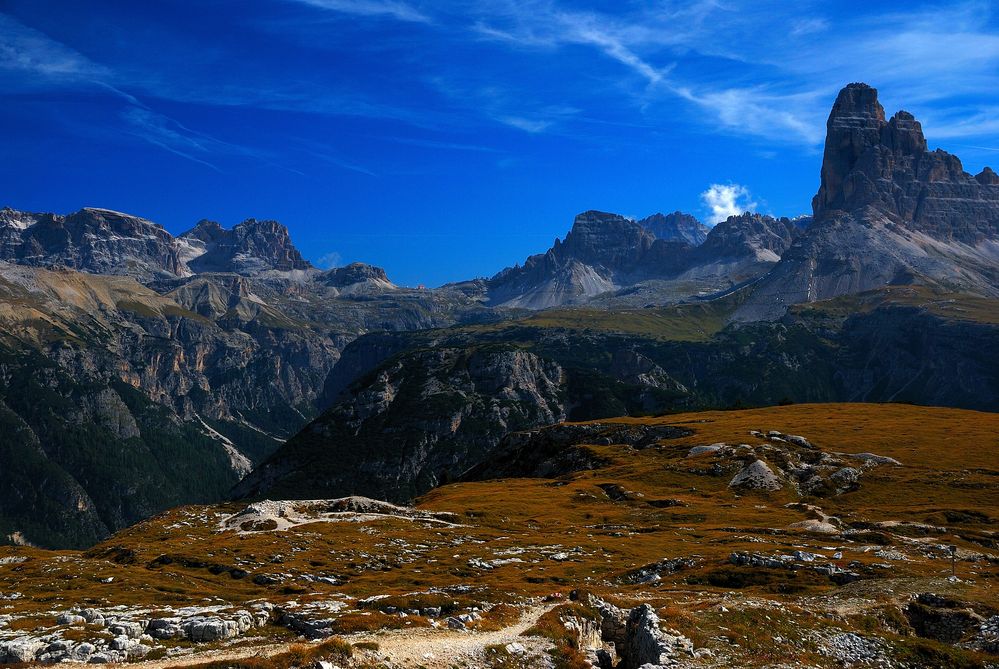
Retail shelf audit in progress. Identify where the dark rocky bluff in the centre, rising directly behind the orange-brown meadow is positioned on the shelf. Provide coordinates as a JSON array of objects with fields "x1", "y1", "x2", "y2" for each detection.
[{"x1": 234, "y1": 346, "x2": 565, "y2": 501}]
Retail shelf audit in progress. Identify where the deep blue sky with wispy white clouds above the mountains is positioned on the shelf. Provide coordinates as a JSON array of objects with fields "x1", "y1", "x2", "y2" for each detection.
[{"x1": 0, "y1": 0, "x2": 999, "y2": 285}]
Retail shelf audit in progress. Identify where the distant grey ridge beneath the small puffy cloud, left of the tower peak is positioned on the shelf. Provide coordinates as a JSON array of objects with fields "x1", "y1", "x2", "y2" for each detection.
[{"x1": 487, "y1": 211, "x2": 801, "y2": 309}]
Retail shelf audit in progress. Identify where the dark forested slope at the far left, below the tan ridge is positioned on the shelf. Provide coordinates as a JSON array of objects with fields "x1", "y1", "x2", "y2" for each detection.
[{"x1": 0, "y1": 344, "x2": 243, "y2": 547}]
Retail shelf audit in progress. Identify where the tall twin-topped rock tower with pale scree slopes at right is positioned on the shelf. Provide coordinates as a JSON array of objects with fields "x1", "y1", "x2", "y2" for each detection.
[{"x1": 736, "y1": 84, "x2": 999, "y2": 320}]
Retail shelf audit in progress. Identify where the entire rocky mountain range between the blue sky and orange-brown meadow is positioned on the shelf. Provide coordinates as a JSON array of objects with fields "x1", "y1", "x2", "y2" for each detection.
[{"x1": 0, "y1": 84, "x2": 999, "y2": 546}]
